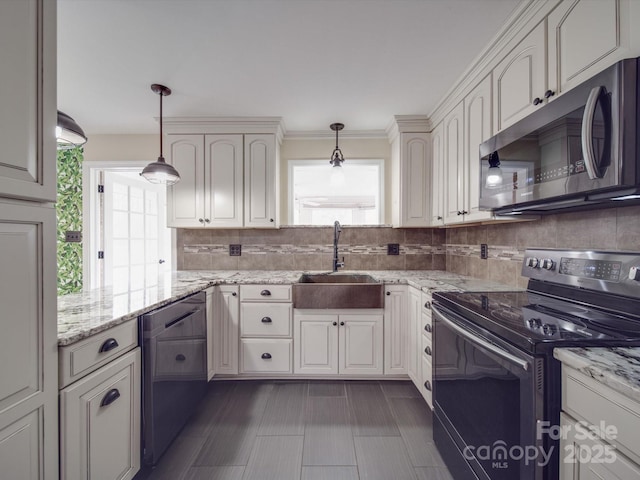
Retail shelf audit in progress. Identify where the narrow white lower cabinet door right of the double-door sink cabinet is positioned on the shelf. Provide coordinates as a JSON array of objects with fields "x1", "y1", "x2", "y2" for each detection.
[{"x1": 384, "y1": 285, "x2": 409, "y2": 375}]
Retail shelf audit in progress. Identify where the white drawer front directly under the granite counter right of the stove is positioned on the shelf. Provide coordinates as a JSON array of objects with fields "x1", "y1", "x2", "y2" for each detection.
[{"x1": 562, "y1": 366, "x2": 640, "y2": 463}]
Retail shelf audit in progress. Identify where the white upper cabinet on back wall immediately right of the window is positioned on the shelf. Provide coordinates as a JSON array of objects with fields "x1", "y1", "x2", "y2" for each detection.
[{"x1": 391, "y1": 127, "x2": 431, "y2": 227}]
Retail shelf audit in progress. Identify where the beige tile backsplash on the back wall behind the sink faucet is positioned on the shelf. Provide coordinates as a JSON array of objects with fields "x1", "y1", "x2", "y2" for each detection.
[{"x1": 177, "y1": 226, "x2": 446, "y2": 271}]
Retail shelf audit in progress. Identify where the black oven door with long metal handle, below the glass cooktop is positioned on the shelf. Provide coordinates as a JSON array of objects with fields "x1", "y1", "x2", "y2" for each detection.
[{"x1": 433, "y1": 304, "x2": 546, "y2": 480}]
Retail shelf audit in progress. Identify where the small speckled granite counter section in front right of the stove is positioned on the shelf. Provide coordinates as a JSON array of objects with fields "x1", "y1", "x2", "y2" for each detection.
[{"x1": 553, "y1": 347, "x2": 640, "y2": 402}]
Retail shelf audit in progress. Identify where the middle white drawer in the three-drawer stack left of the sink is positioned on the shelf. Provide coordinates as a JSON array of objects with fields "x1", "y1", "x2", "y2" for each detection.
[{"x1": 240, "y1": 303, "x2": 293, "y2": 337}]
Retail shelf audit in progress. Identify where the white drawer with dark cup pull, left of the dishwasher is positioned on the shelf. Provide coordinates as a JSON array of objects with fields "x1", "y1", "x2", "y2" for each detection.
[{"x1": 58, "y1": 320, "x2": 138, "y2": 388}]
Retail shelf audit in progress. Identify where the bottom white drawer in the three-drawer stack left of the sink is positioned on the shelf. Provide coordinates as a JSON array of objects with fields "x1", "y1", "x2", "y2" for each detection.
[{"x1": 240, "y1": 338, "x2": 292, "y2": 373}]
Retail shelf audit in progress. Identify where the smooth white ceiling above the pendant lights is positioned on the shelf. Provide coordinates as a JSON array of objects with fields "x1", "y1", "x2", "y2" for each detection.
[{"x1": 58, "y1": 0, "x2": 520, "y2": 136}]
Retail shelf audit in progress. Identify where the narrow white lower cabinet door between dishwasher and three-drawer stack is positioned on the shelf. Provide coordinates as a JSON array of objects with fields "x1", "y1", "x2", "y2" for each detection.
[{"x1": 213, "y1": 285, "x2": 240, "y2": 375}]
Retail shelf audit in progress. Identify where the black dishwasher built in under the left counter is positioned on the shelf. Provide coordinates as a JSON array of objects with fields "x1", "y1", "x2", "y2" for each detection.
[{"x1": 139, "y1": 292, "x2": 207, "y2": 466}]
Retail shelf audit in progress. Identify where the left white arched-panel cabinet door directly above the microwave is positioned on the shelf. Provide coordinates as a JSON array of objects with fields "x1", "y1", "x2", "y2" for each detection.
[{"x1": 493, "y1": 22, "x2": 547, "y2": 132}]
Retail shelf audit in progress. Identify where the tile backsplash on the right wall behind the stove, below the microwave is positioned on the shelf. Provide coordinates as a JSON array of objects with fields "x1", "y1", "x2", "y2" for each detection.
[{"x1": 446, "y1": 206, "x2": 640, "y2": 287}]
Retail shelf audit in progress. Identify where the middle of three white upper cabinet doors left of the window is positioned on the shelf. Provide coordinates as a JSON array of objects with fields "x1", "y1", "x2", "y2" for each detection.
[{"x1": 204, "y1": 135, "x2": 243, "y2": 227}]
